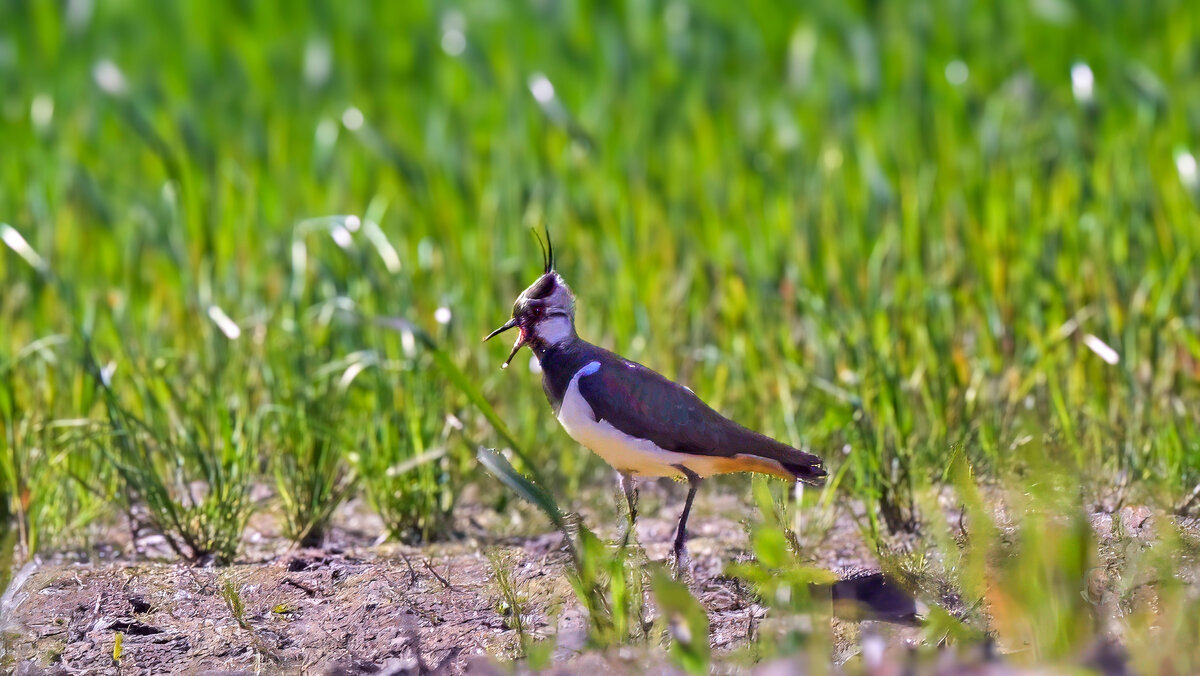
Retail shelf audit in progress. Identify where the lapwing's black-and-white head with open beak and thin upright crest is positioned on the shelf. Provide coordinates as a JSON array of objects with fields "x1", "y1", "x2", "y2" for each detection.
[{"x1": 484, "y1": 232, "x2": 575, "y2": 369}]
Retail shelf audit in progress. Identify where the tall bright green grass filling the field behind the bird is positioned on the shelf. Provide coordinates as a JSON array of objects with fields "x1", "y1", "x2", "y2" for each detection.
[{"x1": 0, "y1": 0, "x2": 1200, "y2": 672}]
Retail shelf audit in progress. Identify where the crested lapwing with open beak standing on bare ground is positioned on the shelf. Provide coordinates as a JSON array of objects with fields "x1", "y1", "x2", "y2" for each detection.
[{"x1": 484, "y1": 232, "x2": 826, "y2": 570}]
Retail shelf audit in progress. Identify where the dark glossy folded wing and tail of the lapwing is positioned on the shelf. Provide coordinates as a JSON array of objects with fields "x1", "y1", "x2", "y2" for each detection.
[{"x1": 580, "y1": 355, "x2": 826, "y2": 483}]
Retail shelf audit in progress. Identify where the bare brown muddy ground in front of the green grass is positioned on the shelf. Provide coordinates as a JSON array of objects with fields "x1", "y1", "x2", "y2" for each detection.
[{"x1": 0, "y1": 481, "x2": 1190, "y2": 674}]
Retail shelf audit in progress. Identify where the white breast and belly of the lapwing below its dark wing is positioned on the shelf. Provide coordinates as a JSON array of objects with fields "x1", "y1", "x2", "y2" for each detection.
[{"x1": 558, "y1": 361, "x2": 718, "y2": 477}]
